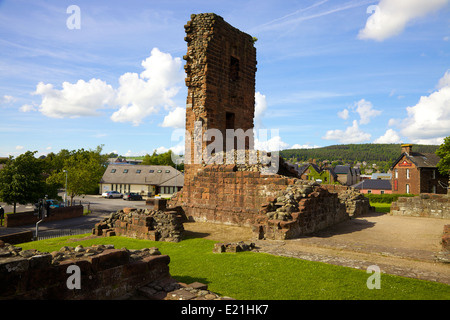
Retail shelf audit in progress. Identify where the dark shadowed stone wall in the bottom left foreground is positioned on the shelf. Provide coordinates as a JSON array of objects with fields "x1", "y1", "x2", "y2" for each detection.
[{"x1": 0, "y1": 241, "x2": 170, "y2": 300}]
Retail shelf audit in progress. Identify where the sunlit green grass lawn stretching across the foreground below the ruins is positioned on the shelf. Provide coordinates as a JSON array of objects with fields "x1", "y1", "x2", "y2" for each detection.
[{"x1": 17, "y1": 235, "x2": 450, "y2": 300}]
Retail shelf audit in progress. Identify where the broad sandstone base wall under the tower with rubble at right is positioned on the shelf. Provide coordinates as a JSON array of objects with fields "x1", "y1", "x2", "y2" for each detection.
[{"x1": 168, "y1": 165, "x2": 370, "y2": 239}]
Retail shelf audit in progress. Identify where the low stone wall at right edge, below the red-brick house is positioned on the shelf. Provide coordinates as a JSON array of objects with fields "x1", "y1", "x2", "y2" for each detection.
[{"x1": 390, "y1": 194, "x2": 450, "y2": 219}]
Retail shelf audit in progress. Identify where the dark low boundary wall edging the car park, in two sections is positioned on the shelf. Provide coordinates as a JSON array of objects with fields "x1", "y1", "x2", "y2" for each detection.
[{"x1": 5, "y1": 205, "x2": 83, "y2": 228}]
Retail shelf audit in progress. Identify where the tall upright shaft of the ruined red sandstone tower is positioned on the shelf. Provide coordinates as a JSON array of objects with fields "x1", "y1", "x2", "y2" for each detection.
[{"x1": 183, "y1": 13, "x2": 256, "y2": 179}]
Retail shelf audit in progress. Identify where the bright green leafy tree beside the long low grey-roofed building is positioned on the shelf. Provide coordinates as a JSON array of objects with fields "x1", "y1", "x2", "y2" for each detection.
[{"x1": 47, "y1": 146, "x2": 108, "y2": 203}]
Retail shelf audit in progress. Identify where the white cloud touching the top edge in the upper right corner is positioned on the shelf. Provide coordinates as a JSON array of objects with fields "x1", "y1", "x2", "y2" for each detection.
[{"x1": 358, "y1": 0, "x2": 449, "y2": 41}]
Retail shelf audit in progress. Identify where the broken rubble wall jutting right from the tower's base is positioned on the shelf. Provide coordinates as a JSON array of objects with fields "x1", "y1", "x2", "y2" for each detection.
[{"x1": 253, "y1": 179, "x2": 370, "y2": 240}]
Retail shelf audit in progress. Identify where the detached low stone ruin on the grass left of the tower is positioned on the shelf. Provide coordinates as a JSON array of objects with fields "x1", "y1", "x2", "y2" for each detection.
[{"x1": 92, "y1": 208, "x2": 184, "y2": 242}]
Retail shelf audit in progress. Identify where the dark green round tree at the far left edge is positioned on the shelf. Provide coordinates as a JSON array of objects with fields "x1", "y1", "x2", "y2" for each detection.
[{"x1": 0, "y1": 151, "x2": 47, "y2": 213}]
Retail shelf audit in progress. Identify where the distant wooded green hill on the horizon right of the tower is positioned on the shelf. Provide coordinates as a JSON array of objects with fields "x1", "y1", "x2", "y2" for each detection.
[{"x1": 280, "y1": 143, "x2": 439, "y2": 163}]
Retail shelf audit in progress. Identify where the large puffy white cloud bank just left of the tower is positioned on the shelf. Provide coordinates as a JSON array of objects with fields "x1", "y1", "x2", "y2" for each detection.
[{"x1": 31, "y1": 48, "x2": 184, "y2": 125}]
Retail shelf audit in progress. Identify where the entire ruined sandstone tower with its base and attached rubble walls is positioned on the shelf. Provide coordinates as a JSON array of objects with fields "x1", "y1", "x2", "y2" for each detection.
[{"x1": 168, "y1": 13, "x2": 370, "y2": 239}]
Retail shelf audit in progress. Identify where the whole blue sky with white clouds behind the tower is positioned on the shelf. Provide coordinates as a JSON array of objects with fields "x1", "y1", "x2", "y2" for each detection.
[{"x1": 0, "y1": 0, "x2": 450, "y2": 156}]
